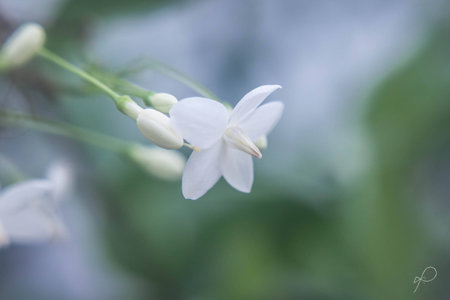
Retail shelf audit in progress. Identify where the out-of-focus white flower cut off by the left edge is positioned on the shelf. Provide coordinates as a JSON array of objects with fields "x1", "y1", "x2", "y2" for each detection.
[{"x1": 0, "y1": 163, "x2": 72, "y2": 246}]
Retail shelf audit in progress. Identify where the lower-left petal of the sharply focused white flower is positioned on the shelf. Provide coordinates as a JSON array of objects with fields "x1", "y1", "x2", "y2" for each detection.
[{"x1": 182, "y1": 141, "x2": 223, "y2": 200}]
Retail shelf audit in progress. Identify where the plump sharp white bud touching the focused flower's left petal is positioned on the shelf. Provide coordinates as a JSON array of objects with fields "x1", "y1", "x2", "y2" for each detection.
[{"x1": 137, "y1": 108, "x2": 184, "y2": 149}]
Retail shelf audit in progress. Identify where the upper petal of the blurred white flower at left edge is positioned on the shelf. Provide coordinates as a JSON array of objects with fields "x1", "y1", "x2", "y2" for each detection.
[{"x1": 0, "y1": 180, "x2": 54, "y2": 214}]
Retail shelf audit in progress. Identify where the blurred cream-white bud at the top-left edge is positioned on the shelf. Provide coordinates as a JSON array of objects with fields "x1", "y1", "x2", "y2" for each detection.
[{"x1": 0, "y1": 23, "x2": 45, "y2": 68}]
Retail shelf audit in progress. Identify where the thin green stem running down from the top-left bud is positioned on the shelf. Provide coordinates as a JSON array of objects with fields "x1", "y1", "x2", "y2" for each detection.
[{"x1": 38, "y1": 48, "x2": 121, "y2": 105}]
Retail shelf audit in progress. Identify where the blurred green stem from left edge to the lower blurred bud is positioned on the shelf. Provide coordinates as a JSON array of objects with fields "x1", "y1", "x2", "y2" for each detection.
[{"x1": 0, "y1": 110, "x2": 132, "y2": 154}]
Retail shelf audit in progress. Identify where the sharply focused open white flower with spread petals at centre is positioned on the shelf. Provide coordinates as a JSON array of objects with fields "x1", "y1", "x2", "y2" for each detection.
[{"x1": 170, "y1": 85, "x2": 283, "y2": 200}]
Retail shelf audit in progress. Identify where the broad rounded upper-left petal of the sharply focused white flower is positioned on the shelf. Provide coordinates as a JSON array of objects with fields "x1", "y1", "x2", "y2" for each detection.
[{"x1": 170, "y1": 97, "x2": 228, "y2": 149}]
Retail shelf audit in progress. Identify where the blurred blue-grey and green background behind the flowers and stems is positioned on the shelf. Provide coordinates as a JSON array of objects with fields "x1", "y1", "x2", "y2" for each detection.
[{"x1": 0, "y1": 0, "x2": 450, "y2": 299}]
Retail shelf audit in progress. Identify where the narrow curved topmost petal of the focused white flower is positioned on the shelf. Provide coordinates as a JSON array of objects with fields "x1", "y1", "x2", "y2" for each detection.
[{"x1": 229, "y1": 85, "x2": 281, "y2": 125}]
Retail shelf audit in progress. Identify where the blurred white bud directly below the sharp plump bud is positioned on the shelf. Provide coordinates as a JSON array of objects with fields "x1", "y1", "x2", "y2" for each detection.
[{"x1": 129, "y1": 145, "x2": 186, "y2": 180}]
